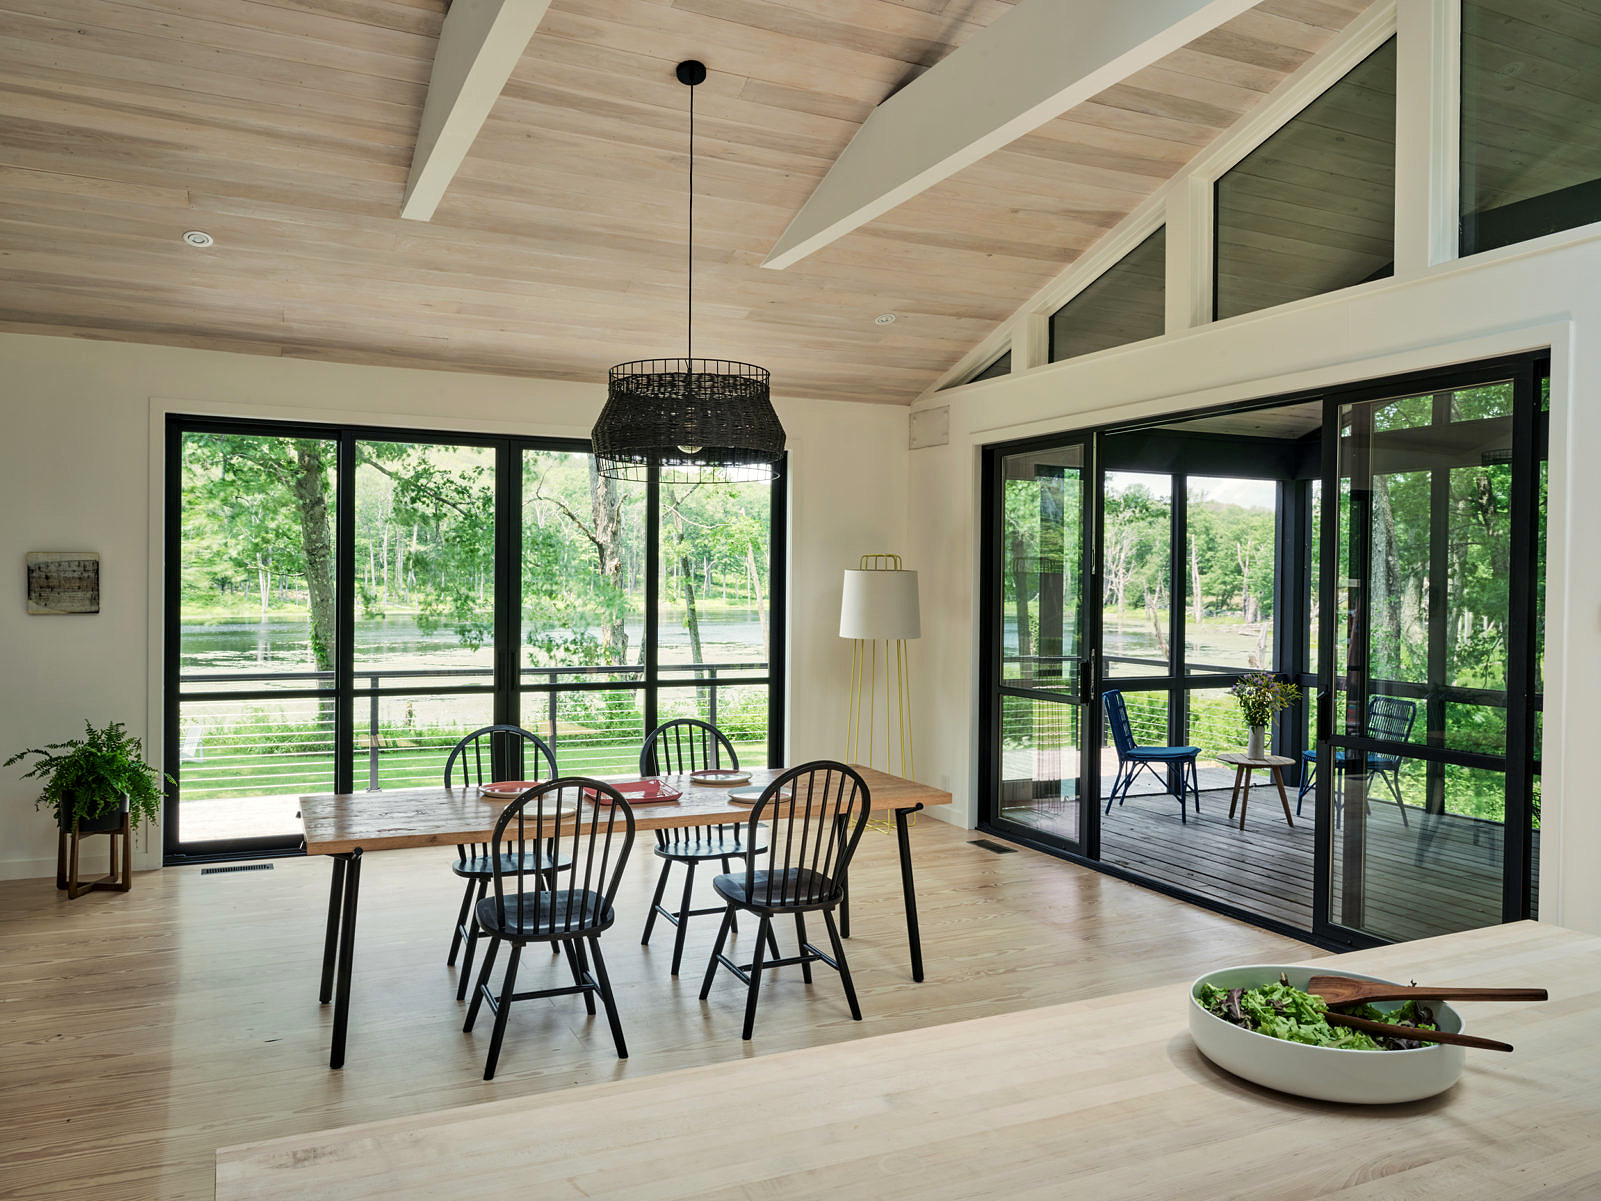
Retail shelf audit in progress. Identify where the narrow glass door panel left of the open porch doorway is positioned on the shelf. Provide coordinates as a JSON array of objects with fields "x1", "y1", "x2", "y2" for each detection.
[{"x1": 985, "y1": 442, "x2": 1098, "y2": 850}]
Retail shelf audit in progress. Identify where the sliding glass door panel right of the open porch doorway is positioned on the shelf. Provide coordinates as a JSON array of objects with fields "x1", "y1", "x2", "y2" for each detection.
[{"x1": 1316, "y1": 360, "x2": 1545, "y2": 940}]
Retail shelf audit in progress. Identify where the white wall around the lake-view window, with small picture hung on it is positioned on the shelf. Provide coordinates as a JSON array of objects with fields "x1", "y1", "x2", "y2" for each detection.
[{"x1": 0, "y1": 335, "x2": 906, "y2": 878}]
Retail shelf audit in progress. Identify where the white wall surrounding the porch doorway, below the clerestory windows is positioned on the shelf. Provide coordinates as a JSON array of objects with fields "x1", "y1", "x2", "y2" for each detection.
[{"x1": 909, "y1": 227, "x2": 1601, "y2": 932}]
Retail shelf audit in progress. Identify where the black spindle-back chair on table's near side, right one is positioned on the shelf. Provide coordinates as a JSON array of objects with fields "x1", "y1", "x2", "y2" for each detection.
[{"x1": 701, "y1": 759, "x2": 869, "y2": 1041}]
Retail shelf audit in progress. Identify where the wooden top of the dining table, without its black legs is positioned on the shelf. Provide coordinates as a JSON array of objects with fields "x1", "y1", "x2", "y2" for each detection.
[{"x1": 299, "y1": 765, "x2": 951, "y2": 855}]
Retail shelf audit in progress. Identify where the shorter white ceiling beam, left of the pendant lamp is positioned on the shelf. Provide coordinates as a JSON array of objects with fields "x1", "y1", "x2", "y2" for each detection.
[{"x1": 400, "y1": 0, "x2": 551, "y2": 221}]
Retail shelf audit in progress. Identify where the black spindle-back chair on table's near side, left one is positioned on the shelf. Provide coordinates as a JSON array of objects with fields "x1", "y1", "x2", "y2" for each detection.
[{"x1": 461, "y1": 777, "x2": 634, "y2": 1079}]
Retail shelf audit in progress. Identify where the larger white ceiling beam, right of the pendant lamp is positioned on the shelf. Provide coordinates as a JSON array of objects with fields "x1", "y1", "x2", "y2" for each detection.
[{"x1": 762, "y1": 0, "x2": 1255, "y2": 267}]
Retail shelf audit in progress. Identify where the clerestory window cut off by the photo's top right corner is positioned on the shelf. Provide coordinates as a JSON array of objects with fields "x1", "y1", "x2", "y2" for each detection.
[{"x1": 1462, "y1": 0, "x2": 1601, "y2": 255}]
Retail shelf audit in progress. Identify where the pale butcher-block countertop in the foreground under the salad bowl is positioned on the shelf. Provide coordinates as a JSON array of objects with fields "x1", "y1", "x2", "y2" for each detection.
[{"x1": 216, "y1": 922, "x2": 1601, "y2": 1201}]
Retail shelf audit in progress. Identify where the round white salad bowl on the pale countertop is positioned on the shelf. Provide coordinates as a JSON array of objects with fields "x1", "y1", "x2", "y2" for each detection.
[{"x1": 1190, "y1": 964, "x2": 1465, "y2": 1105}]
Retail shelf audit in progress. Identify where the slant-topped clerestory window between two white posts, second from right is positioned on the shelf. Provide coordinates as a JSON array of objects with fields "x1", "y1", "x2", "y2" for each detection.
[{"x1": 1214, "y1": 38, "x2": 1396, "y2": 320}]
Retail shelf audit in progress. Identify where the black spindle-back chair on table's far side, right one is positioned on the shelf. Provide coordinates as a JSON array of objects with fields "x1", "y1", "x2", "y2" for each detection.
[{"x1": 639, "y1": 717, "x2": 778, "y2": 975}]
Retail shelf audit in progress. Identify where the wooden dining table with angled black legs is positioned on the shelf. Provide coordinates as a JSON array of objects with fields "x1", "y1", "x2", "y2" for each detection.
[{"x1": 299, "y1": 764, "x2": 951, "y2": 1068}]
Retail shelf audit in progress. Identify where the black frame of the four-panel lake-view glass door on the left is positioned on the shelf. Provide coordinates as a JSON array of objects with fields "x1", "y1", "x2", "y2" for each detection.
[{"x1": 162, "y1": 413, "x2": 789, "y2": 863}]
